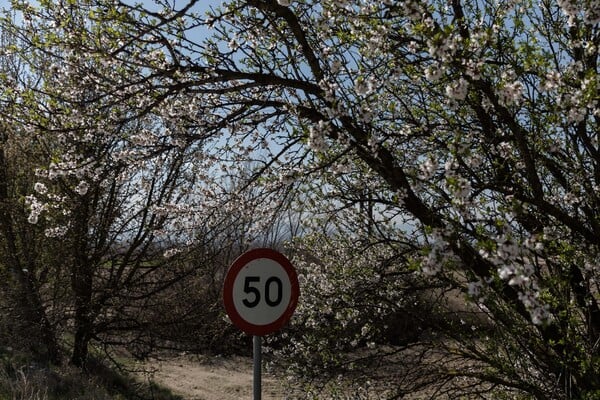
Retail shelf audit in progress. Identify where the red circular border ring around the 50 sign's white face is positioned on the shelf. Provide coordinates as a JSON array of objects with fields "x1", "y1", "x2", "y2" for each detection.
[{"x1": 223, "y1": 248, "x2": 300, "y2": 336}]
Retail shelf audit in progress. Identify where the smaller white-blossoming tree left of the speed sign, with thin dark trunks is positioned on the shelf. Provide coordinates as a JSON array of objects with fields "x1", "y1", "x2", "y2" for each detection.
[{"x1": 0, "y1": 4, "x2": 241, "y2": 367}]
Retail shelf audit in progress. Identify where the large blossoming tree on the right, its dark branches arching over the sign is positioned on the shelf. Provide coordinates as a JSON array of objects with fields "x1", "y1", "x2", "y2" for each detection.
[{"x1": 2, "y1": 0, "x2": 600, "y2": 399}]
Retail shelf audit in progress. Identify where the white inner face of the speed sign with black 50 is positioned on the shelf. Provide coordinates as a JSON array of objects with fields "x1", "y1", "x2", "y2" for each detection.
[{"x1": 233, "y1": 258, "x2": 292, "y2": 325}]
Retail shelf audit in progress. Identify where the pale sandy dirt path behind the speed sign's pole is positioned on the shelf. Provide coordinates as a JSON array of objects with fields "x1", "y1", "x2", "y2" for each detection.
[{"x1": 142, "y1": 357, "x2": 287, "y2": 400}]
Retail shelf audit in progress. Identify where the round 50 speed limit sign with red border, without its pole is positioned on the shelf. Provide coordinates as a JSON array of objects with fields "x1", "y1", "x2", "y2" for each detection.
[{"x1": 223, "y1": 248, "x2": 300, "y2": 336}]
